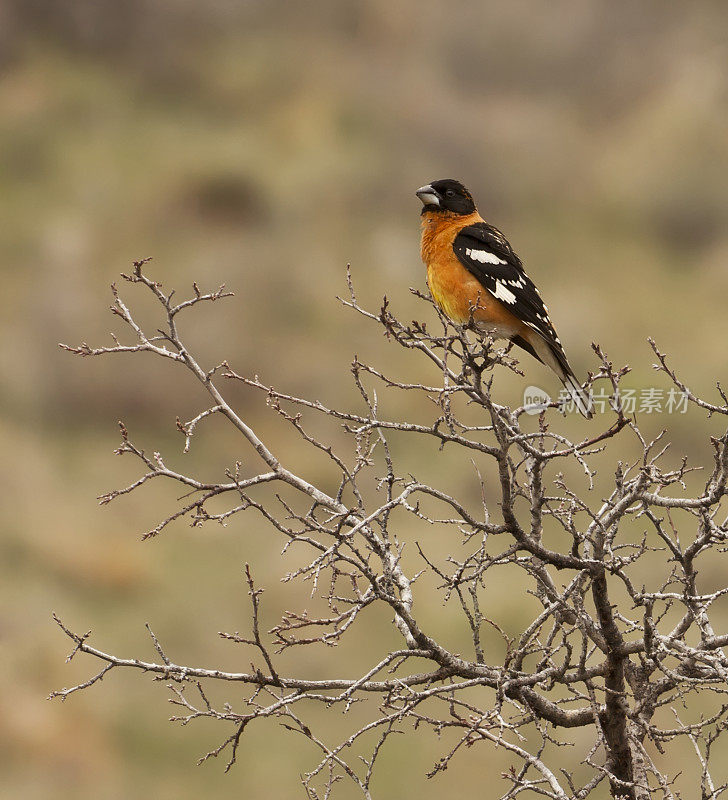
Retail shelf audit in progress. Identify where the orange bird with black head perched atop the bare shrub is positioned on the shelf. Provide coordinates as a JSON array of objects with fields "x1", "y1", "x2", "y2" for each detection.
[{"x1": 416, "y1": 180, "x2": 592, "y2": 419}]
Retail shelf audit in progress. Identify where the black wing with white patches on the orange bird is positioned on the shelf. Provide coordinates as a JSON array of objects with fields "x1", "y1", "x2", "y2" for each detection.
[{"x1": 453, "y1": 222, "x2": 563, "y2": 352}]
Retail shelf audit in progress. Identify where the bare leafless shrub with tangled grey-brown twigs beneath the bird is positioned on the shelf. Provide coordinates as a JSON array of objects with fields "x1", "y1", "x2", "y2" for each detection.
[{"x1": 51, "y1": 261, "x2": 728, "y2": 800}]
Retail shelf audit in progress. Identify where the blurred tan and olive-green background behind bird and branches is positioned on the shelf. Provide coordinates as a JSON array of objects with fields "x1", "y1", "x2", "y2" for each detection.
[{"x1": 0, "y1": 0, "x2": 728, "y2": 800}]
